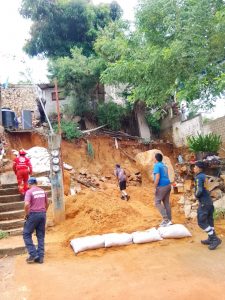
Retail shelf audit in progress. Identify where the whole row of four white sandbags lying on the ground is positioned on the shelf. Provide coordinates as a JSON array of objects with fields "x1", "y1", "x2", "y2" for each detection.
[{"x1": 70, "y1": 224, "x2": 191, "y2": 254}]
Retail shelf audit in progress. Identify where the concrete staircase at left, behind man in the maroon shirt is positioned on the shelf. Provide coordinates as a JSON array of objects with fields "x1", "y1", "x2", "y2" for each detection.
[{"x1": 0, "y1": 183, "x2": 51, "y2": 257}]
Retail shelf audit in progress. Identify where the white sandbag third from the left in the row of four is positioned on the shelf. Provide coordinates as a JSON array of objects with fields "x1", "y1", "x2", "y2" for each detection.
[{"x1": 132, "y1": 228, "x2": 162, "y2": 244}]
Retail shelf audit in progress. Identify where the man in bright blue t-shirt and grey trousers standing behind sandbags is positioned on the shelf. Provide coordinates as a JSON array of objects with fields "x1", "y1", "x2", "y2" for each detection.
[{"x1": 153, "y1": 153, "x2": 172, "y2": 227}]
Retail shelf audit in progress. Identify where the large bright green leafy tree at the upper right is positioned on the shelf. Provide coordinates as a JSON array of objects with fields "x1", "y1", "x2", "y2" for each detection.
[{"x1": 95, "y1": 0, "x2": 225, "y2": 108}]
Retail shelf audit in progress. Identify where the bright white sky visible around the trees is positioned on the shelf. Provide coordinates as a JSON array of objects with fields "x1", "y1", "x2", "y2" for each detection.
[{"x1": 0, "y1": 0, "x2": 225, "y2": 118}]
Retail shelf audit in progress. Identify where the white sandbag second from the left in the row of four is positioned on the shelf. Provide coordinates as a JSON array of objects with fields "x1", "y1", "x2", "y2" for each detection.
[{"x1": 103, "y1": 233, "x2": 133, "y2": 248}]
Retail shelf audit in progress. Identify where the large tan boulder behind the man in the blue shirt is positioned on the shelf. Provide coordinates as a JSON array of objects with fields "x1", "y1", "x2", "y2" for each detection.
[{"x1": 135, "y1": 149, "x2": 175, "y2": 182}]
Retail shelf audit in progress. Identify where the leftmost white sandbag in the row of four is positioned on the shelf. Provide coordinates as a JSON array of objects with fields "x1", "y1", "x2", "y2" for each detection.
[{"x1": 70, "y1": 235, "x2": 105, "y2": 254}]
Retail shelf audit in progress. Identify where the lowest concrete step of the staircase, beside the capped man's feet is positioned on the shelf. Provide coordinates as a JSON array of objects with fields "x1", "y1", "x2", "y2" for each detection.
[{"x1": 0, "y1": 236, "x2": 26, "y2": 257}]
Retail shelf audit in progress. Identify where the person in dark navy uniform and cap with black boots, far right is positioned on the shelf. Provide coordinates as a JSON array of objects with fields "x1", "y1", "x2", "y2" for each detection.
[{"x1": 194, "y1": 161, "x2": 222, "y2": 250}]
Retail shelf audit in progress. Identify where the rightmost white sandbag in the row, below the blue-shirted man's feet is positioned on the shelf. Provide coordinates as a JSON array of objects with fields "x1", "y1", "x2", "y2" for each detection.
[{"x1": 158, "y1": 224, "x2": 191, "y2": 239}]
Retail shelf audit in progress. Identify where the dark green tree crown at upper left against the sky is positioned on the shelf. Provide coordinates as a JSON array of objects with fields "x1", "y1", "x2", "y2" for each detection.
[{"x1": 20, "y1": 0, "x2": 121, "y2": 57}]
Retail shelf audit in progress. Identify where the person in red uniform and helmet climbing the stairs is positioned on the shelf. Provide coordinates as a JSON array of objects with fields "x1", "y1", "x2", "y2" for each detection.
[{"x1": 13, "y1": 150, "x2": 32, "y2": 195}]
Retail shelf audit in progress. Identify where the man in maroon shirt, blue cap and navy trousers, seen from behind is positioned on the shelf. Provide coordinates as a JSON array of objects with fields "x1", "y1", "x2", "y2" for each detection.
[{"x1": 23, "y1": 177, "x2": 49, "y2": 263}]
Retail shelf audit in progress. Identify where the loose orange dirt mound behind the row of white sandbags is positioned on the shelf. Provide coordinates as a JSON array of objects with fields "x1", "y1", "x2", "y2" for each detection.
[{"x1": 52, "y1": 184, "x2": 184, "y2": 247}]
